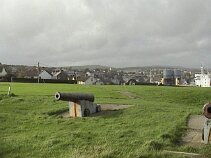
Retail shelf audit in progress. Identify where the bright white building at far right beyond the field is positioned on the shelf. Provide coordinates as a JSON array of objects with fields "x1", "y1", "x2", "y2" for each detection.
[{"x1": 195, "y1": 74, "x2": 210, "y2": 87}]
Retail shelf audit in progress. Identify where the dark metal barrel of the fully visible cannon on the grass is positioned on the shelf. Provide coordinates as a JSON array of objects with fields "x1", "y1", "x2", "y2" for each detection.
[{"x1": 55, "y1": 92, "x2": 94, "y2": 102}]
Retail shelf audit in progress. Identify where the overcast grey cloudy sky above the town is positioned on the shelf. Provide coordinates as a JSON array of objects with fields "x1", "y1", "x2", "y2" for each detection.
[{"x1": 0, "y1": 0, "x2": 211, "y2": 68}]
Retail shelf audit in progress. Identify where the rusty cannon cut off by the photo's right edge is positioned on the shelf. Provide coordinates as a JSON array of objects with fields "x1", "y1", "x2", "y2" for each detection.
[{"x1": 202, "y1": 103, "x2": 211, "y2": 144}]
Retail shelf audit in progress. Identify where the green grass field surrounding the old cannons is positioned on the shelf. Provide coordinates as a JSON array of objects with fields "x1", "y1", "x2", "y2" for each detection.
[{"x1": 0, "y1": 83, "x2": 211, "y2": 158}]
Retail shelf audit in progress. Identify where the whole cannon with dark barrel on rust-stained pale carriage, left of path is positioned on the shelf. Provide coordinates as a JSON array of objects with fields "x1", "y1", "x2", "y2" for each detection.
[{"x1": 55, "y1": 92, "x2": 101, "y2": 117}]
